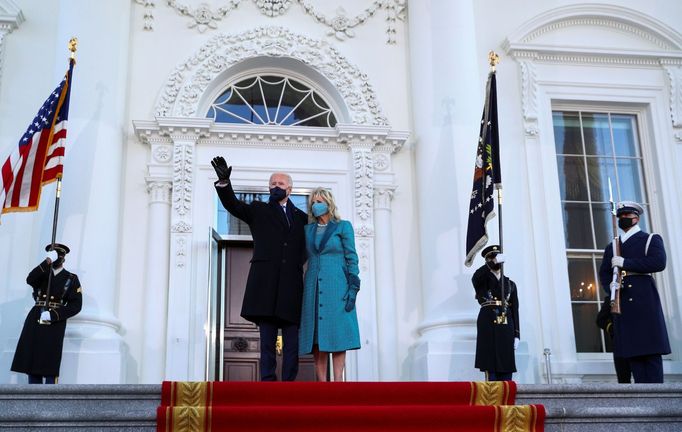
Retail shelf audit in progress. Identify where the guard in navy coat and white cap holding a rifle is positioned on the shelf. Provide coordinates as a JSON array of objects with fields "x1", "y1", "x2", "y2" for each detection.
[{"x1": 599, "y1": 201, "x2": 670, "y2": 383}]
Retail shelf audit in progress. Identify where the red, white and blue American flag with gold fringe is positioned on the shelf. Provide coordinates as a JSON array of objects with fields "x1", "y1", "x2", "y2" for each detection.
[{"x1": 0, "y1": 60, "x2": 75, "y2": 218}]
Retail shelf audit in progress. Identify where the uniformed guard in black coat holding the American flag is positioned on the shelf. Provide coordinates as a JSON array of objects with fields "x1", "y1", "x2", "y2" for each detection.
[{"x1": 12, "y1": 243, "x2": 83, "y2": 384}]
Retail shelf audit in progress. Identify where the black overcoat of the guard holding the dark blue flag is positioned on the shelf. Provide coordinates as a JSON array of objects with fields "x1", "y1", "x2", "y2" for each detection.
[{"x1": 471, "y1": 264, "x2": 521, "y2": 373}]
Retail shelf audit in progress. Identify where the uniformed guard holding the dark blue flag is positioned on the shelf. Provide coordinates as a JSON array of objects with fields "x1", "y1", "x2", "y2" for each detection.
[{"x1": 471, "y1": 245, "x2": 521, "y2": 381}]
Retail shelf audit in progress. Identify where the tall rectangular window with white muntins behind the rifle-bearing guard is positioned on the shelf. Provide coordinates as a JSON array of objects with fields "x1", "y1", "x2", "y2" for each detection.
[{"x1": 552, "y1": 108, "x2": 649, "y2": 353}]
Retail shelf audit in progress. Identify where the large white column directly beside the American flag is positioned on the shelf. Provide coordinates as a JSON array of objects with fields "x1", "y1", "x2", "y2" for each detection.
[{"x1": 54, "y1": 0, "x2": 131, "y2": 383}]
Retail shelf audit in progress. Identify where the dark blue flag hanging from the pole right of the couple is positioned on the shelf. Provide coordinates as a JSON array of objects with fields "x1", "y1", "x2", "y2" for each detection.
[{"x1": 464, "y1": 71, "x2": 502, "y2": 267}]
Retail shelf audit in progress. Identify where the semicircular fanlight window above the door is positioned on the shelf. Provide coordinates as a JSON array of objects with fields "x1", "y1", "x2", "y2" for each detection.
[{"x1": 206, "y1": 75, "x2": 336, "y2": 127}]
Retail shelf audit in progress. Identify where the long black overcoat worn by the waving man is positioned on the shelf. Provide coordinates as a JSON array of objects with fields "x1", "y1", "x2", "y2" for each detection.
[{"x1": 216, "y1": 182, "x2": 308, "y2": 324}]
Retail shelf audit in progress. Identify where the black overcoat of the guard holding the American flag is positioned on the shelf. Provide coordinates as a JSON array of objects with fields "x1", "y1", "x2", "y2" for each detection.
[{"x1": 12, "y1": 260, "x2": 83, "y2": 376}]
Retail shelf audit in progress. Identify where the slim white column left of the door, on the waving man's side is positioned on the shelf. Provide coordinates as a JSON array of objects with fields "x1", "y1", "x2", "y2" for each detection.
[{"x1": 140, "y1": 179, "x2": 171, "y2": 383}]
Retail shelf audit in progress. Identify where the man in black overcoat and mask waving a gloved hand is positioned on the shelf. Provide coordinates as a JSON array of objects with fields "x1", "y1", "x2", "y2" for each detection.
[{"x1": 211, "y1": 157, "x2": 308, "y2": 381}]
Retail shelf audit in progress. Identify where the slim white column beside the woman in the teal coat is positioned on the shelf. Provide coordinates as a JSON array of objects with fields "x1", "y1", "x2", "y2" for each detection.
[{"x1": 374, "y1": 185, "x2": 400, "y2": 381}]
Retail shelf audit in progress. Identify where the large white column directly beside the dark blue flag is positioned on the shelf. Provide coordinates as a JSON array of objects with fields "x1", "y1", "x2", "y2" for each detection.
[{"x1": 408, "y1": 0, "x2": 480, "y2": 380}]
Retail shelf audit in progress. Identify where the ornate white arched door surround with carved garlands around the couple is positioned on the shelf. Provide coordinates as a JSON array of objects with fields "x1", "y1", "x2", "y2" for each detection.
[{"x1": 133, "y1": 27, "x2": 408, "y2": 382}]
